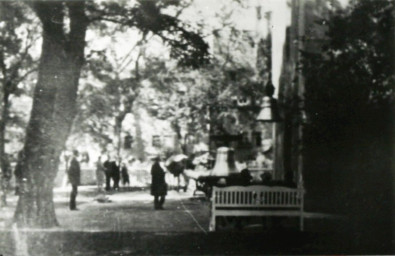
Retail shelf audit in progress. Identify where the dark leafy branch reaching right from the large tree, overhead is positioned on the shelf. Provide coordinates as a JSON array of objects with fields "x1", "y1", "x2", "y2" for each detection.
[{"x1": 90, "y1": 1, "x2": 209, "y2": 68}]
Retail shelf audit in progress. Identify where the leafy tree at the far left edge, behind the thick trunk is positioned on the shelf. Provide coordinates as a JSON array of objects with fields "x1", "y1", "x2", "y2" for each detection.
[{"x1": 0, "y1": 2, "x2": 38, "y2": 206}]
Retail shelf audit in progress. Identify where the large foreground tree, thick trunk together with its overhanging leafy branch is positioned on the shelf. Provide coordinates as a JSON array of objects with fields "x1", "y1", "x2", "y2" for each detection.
[{"x1": 14, "y1": 1, "x2": 208, "y2": 227}]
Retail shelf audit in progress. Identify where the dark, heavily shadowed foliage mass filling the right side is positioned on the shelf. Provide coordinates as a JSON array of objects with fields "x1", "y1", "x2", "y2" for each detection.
[{"x1": 303, "y1": 0, "x2": 395, "y2": 250}]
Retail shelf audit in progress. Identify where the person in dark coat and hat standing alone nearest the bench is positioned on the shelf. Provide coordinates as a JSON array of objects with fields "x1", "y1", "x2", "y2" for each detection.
[{"x1": 151, "y1": 157, "x2": 167, "y2": 210}]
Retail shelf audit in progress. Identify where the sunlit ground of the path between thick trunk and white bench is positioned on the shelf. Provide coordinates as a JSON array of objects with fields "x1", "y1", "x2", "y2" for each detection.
[{"x1": 56, "y1": 188, "x2": 209, "y2": 233}]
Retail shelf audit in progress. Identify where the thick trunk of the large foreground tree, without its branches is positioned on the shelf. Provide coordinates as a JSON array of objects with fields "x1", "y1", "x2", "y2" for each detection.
[{"x1": 14, "y1": 1, "x2": 87, "y2": 227}]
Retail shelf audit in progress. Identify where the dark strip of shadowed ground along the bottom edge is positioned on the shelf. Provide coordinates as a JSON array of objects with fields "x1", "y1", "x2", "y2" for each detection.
[{"x1": 0, "y1": 227, "x2": 392, "y2": 256}]
